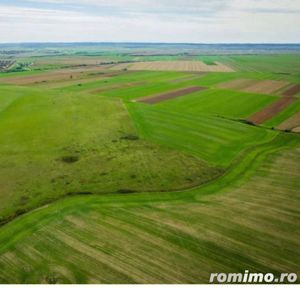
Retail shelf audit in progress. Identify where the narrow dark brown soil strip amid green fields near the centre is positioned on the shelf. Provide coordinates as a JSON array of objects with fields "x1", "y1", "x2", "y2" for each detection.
[{"x1": 137, "y1": 86, "x2": 206, "y2": 104}]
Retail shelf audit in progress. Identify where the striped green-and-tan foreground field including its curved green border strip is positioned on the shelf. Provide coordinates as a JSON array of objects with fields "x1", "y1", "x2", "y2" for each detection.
[{"x1": 0, "y1": 134, "x2": 300, "y2": 283}]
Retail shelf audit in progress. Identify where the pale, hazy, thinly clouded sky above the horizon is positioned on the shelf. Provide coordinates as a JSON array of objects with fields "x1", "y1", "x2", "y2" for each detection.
[{"x1": 0, "y1": 0, "x2": 300, "y2": 43}]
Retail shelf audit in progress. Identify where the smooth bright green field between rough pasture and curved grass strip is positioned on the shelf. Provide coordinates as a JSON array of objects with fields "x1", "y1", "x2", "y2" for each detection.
[{"x1": 130, "y1": 104, "x2": 276, "y2": 167}]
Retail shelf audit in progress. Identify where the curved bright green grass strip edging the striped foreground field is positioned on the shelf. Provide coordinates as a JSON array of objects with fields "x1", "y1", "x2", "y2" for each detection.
[{"x1": 0, "y1": 133, "x2": 300, "y2": 252}]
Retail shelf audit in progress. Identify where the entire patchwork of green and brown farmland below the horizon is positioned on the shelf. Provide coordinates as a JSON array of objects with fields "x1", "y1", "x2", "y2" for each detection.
[{"x1": 0, "y1": 44, "x2": 300, "y2": 283}]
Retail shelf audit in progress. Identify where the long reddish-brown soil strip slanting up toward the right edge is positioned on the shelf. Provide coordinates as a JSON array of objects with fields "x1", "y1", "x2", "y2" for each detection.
[{"x1": 248, "y1": 97, "x2": 296, "y2": 125}]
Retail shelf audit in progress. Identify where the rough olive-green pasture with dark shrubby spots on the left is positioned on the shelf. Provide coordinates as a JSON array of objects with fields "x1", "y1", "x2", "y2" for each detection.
[{"x1": 0, "y1": 87, "x2": 221, "y2": 223}]
